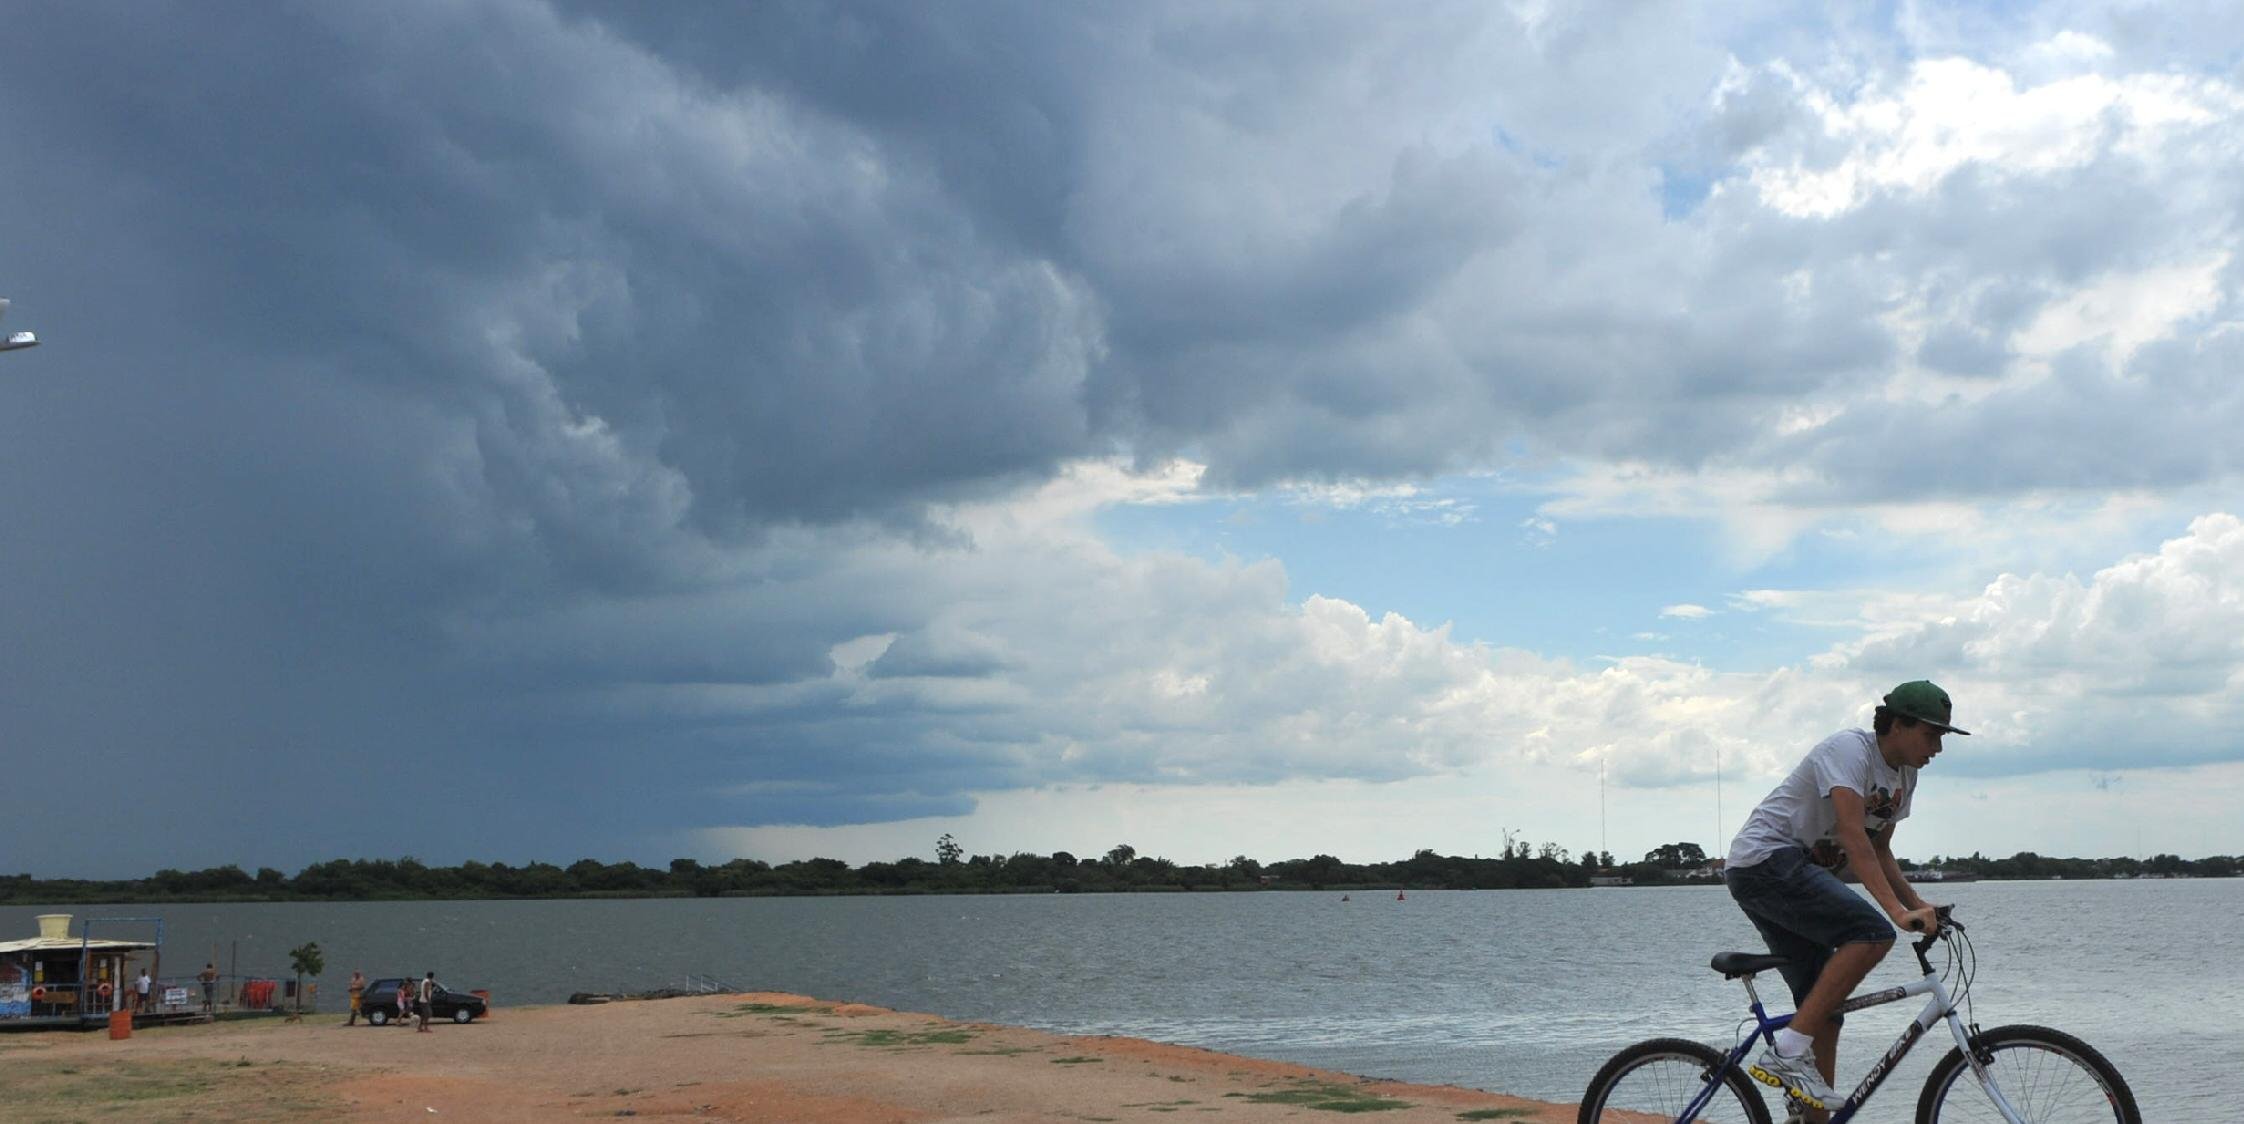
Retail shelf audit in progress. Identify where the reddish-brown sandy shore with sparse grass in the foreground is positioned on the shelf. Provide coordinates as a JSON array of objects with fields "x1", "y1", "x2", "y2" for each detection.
[{"x1": 0, "y1": 992, "x2": 1573, "y2": 1124}]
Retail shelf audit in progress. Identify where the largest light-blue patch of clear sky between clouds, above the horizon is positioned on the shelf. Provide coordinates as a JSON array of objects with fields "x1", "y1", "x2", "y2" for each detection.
[{"x1": 1100, "y1": 480, "x2": 1860, "y2": 669}]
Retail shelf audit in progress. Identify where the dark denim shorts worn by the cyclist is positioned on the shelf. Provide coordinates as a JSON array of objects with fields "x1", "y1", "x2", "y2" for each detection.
[{"x1": 1723, "y1": 848, "x2": 1894, "y2": 1023}]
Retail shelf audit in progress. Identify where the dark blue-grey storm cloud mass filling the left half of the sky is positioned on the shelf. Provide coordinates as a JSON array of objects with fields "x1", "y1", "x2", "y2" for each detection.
[{"x1": 0, "y1": 4, "x2": 1095, "y2": 870}]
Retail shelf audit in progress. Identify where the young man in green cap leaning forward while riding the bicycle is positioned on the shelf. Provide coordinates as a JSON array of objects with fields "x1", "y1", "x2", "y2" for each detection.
[{"x1": 1723, "y1": 680, "x2": 1968, "y2": 1120}]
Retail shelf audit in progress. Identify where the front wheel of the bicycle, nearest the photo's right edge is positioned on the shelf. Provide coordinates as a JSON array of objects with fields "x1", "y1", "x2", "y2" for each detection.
[{"x1": 1916, "y1": 1023, "x2": 2143, "y2": 1124}]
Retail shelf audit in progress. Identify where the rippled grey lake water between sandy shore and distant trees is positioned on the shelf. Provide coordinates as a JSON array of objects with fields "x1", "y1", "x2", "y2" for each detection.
[{"x1": 0, "y1": 879, "x2": 2244, "y2": 1122}]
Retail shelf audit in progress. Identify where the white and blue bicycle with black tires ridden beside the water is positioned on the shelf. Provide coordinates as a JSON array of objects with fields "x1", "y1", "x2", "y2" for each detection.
[{"x1": 1578, "y1": 906, "x2": 2143, "y2": 1124}]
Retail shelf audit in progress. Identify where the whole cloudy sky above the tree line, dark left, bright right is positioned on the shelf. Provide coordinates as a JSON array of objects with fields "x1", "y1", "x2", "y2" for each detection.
[{"x1": 0, "y1": 0, "x2": 2244, "y2": 877}]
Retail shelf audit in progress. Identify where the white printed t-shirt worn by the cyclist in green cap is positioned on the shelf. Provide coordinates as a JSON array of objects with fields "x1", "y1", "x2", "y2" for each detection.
[{"x1": 1728, "y1": 729, "x2": 1916, "y2": 870}]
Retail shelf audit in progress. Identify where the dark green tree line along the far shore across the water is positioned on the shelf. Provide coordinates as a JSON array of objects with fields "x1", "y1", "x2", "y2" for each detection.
[{"x1": 0, "y1": 835, "x2": 2244, "y2": 904}]
